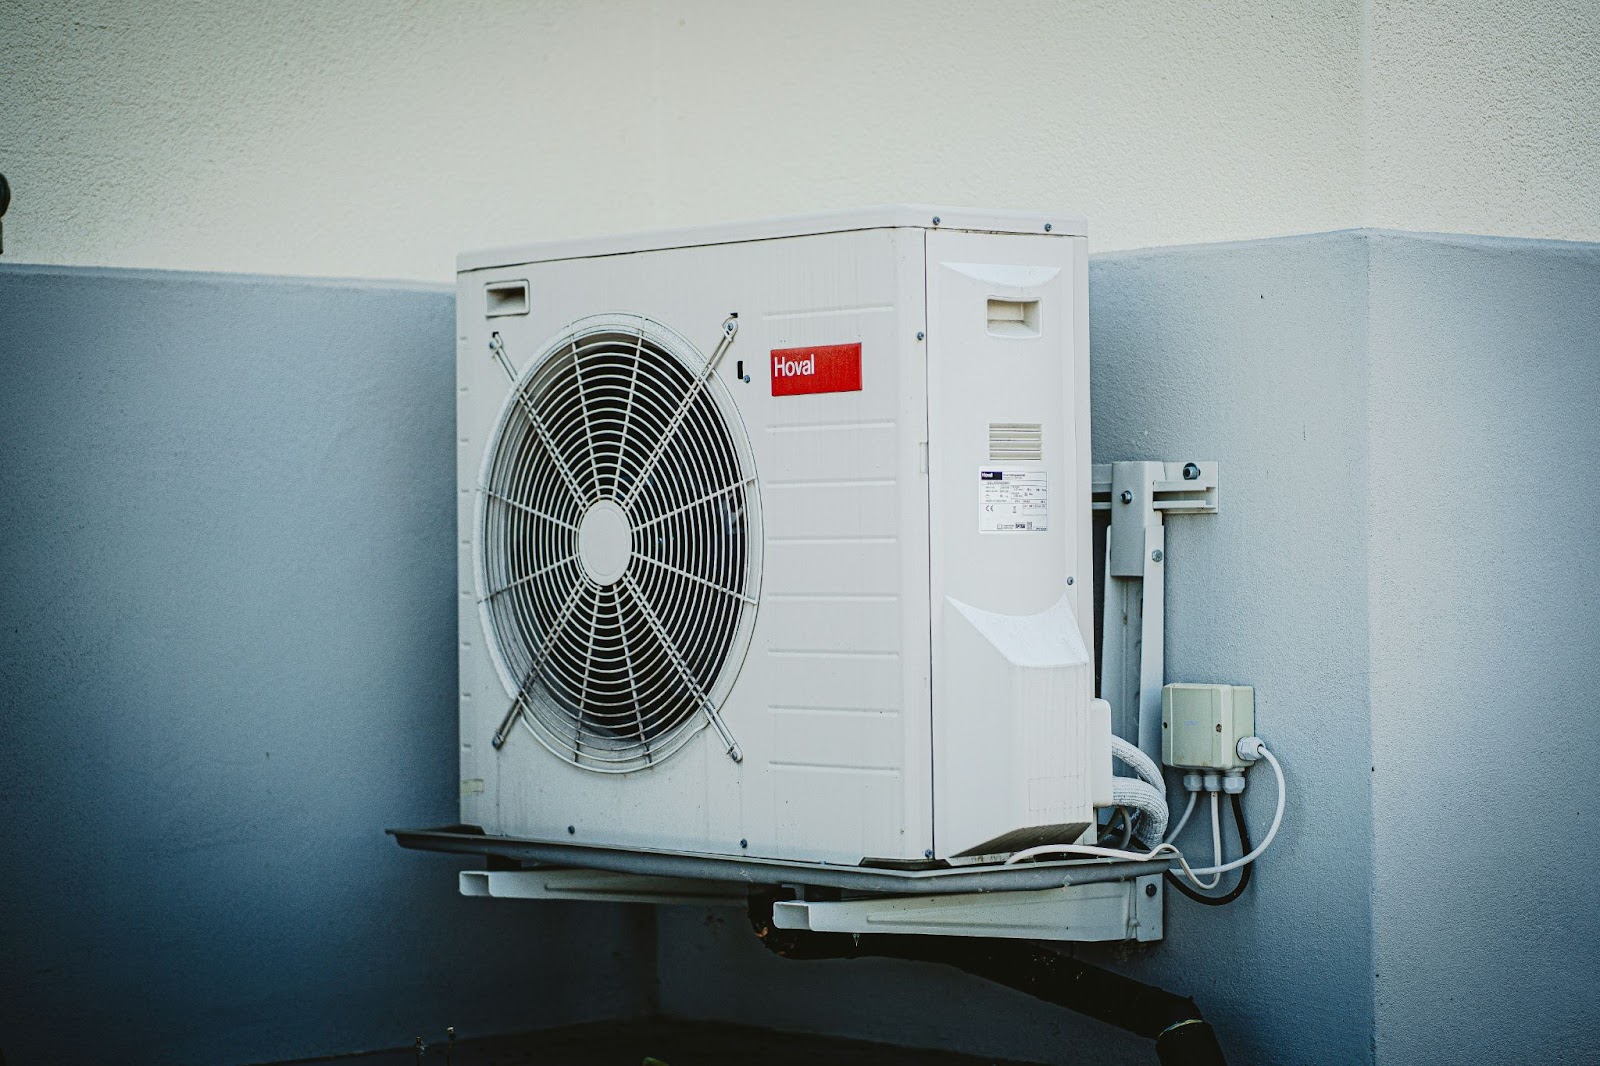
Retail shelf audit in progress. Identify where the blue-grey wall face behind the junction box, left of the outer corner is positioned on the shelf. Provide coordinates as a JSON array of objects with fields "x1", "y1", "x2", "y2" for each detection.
[{"x1": 1090, "y1": 234, "x2": 1373, "y2": 1063}]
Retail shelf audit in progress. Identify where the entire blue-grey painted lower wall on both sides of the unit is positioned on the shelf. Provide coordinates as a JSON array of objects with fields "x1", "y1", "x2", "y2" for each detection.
[{"x1": 0, "y1": 232, "x2": 1600, "y2": 1066}]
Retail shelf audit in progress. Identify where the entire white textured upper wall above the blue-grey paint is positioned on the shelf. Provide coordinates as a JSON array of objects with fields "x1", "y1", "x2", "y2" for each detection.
[{"x1": 0, "y1": 0, "x2": 1600, "y2": 280}]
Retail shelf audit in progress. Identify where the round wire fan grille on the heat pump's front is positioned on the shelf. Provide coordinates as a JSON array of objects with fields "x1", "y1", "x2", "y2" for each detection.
[{"x1": 477, "y1": 317, "x2": 760, "y2": 773}]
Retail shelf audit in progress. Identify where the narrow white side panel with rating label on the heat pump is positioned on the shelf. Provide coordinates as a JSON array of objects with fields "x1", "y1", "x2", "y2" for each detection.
[{"x1": 926, "y1": 230, "x2": 1109, "y2": 858}]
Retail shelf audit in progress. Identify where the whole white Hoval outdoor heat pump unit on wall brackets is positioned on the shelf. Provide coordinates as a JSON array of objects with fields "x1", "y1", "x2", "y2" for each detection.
[{"x1": 458, "y1": 208, "x2": 1112, "y2": 868}]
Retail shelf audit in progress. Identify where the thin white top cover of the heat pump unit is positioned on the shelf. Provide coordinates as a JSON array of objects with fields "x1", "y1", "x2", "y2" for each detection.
[{"x1": 456, "y1": 203, "x2": 1088, "y2": 272}]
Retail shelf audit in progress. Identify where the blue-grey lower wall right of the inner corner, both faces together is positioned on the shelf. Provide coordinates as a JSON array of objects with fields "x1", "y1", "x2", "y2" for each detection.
[{"x1": 659, "y1": 232, "x2": 1600, "y2": 1063}]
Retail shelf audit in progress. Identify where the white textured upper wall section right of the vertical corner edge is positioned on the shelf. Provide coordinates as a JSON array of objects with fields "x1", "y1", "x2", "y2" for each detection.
[{"x1": 1362, "y1": 0, "x2": 1600, "y2": 240}]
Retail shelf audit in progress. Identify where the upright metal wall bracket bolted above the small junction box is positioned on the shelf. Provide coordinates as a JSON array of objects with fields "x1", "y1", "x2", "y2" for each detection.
[{"x1": 1091, "y1": 463, "x2": 1218, "y2": 765}]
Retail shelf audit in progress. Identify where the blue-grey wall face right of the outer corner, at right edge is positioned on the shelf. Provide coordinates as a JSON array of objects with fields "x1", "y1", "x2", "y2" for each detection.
[{"x1": 1368, "y1": 234, "x2": 1600, "y2": 1063}]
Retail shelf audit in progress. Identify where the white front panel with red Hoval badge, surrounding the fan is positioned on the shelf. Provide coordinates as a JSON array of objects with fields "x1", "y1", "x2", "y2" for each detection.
[{"x1": 458, "y1": 229, "x2": 933, "y2": 863}]
